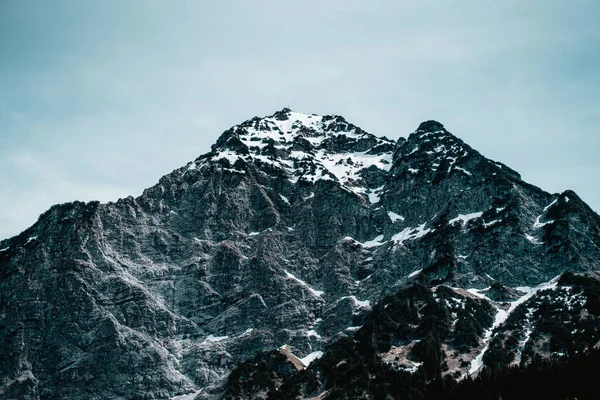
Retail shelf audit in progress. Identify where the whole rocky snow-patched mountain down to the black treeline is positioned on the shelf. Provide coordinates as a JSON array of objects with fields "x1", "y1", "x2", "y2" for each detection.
[{"x1": 0, "y1": 109, "x2": 600, "y2": 399}]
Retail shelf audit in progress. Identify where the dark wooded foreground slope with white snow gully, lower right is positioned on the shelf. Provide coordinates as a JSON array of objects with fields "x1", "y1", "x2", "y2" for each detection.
[{"x1": 224, "y1": 273, "x2": 600, "y2": 399}]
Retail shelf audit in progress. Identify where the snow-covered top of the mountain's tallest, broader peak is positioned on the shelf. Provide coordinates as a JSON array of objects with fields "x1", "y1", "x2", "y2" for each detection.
[{"x1": 199, "y1": 108, "x2": 395, "y2": 200}]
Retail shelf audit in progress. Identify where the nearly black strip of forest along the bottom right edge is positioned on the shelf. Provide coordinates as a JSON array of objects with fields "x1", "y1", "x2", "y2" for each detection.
[{"x1": 225, "y1": 339, "x2": 600, "y2": 400}]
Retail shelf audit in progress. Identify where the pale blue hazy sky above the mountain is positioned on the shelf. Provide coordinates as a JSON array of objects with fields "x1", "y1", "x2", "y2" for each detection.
[{"x1": 0, "y1": 0, "x2": 600, "y2": 239}]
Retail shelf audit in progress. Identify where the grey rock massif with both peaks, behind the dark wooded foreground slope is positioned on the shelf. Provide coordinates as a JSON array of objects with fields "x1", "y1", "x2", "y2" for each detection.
[{"x1": 0, "y1": 109, "x2": 600, "y2": 398}]
